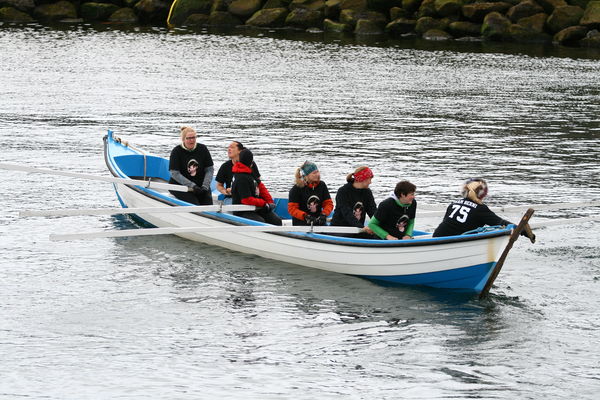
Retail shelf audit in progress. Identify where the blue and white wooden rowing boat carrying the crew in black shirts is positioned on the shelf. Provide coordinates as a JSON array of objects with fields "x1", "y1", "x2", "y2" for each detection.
[{"x1": 104, "y1": 131, "x2": 515, "y2": 293}]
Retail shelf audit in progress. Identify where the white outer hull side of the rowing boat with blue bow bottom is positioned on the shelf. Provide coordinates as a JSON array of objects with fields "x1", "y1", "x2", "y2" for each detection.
[{"x1": 115, "y1": 184, "x2": 509, "y2": 291}]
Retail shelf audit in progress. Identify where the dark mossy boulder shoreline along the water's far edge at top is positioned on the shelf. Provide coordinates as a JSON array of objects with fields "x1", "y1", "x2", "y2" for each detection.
[{"x1": 0, "y1": 0, "x2": 600, "y2": 48}]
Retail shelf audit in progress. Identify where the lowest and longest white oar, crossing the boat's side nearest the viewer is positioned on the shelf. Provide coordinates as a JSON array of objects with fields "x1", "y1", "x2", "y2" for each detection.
[{"x1": 50, "y1": 225, "x2": 361, "y2": 241}]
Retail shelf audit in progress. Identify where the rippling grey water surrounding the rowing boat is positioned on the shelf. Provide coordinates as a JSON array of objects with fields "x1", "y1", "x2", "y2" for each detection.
[{"x1": 0, "y1": 25, "x2": 600, "y2": 399}]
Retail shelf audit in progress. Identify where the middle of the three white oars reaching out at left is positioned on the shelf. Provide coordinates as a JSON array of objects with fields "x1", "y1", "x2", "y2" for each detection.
[{"x1": 19, "y1": 204, "x2": 256, "y2": 217}]
